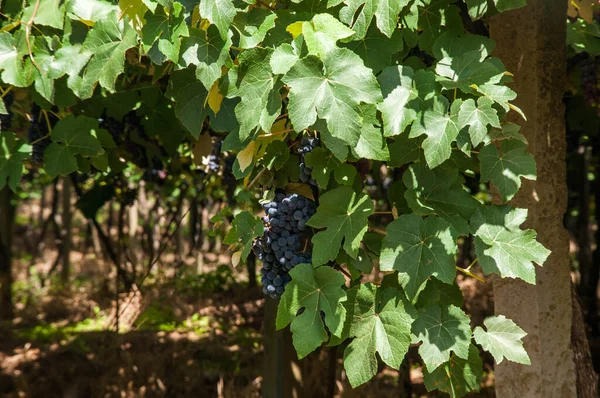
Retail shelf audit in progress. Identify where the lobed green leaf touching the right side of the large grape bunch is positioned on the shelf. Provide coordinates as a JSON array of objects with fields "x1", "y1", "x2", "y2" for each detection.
[{"x1": 306, "y1": 186, "x2": 374, "y2": 266}]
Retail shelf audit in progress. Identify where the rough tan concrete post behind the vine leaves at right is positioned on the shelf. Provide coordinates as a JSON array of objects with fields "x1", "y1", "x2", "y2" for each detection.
[{"x1": 490, "y1": 0, "x2": 576, "y2": 398}]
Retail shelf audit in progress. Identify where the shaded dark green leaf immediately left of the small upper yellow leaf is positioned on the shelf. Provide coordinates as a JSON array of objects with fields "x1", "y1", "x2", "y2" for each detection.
[{"x1": 166, "y1": 68, "x2": 208, "y2": 139}]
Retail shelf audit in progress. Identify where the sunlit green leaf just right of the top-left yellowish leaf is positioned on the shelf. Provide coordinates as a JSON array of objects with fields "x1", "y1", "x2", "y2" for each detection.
[{"x1": 142, "y1": 2, "x2": 189, "y2": 64}]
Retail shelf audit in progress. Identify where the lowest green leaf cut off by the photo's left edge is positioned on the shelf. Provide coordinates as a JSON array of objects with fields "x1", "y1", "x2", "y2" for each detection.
[{"x1": 0, "y1": 131, "x2": 31, "y2": 192}]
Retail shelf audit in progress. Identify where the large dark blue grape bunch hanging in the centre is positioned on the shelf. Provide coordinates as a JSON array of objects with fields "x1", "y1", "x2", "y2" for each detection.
[{"x1": 253, "y1": 193, "x2": 317, "y2": 298}]
